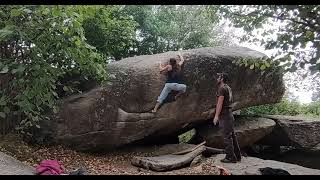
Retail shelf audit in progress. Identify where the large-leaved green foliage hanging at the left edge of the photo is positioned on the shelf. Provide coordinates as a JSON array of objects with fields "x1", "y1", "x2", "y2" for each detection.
[{"x1": 0, "y1": 6, "x2": 106, "y2": 133}]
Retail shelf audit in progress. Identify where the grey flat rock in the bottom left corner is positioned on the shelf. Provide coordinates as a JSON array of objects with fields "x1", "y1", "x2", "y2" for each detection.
[{"x1": 0, "y1": 152, "x2": 35, "y2": 175}]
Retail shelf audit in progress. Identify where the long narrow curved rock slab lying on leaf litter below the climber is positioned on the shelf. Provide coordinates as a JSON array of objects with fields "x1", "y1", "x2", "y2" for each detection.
[{"x1": 131, "y1": 146, "x2": 205, "y2": 171}]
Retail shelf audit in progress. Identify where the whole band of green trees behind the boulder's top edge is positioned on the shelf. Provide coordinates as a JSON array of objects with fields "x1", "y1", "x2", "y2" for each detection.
[{"x1": 78, "y1": 5, "x2": 238, "y2": 60}]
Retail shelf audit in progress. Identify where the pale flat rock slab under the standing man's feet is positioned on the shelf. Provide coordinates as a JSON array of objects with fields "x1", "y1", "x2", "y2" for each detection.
[{"x1": 213, "y1": 154, "x2": 320, "y2": 175}]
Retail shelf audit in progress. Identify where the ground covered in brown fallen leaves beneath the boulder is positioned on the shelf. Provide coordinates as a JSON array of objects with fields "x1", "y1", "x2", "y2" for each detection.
[{"x1": 0, "y1": 134, "x2": 219, "y2": 175}]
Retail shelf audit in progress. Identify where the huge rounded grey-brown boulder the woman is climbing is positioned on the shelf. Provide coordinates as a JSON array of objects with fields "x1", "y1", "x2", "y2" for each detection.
[{"x1": 35, "y1": 47, "x2": 284, "y2": 150}]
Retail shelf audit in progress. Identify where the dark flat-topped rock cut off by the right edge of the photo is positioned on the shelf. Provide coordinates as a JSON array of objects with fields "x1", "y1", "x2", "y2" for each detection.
[{"x1": 261, "y1": 115, "x2": 320, "y2": 151}]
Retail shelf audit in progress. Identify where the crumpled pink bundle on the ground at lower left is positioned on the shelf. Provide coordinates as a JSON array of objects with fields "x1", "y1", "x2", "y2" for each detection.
[{"x1": 36, "y1": 160, "x2": 64, "y2": 175}]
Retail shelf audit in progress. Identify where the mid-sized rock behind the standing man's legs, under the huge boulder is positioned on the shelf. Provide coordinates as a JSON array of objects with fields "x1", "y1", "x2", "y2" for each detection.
[{"x1": 196, "y1": 116, "x2": 276, "y2": 148}]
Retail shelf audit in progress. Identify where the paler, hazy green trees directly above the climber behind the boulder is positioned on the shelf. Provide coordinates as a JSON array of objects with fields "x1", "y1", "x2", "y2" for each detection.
[{"x1": 123, "y1": 5, "x2": 225, "y2": 55}]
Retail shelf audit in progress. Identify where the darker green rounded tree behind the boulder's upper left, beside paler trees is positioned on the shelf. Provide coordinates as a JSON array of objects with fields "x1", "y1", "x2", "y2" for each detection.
[{"x1": 83, "y1": 6, "x2": 137, "y2": 60}]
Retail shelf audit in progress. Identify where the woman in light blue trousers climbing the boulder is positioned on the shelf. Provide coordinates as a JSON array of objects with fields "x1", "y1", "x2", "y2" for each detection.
[{"x1": 152, "y1": 53, "x2": 187, "y2": 113}]
